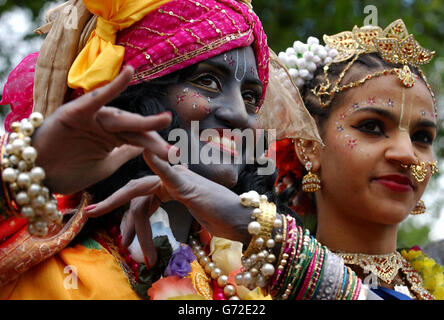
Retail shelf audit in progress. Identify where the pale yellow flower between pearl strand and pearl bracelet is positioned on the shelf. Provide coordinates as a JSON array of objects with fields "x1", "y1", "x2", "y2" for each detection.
[{"x1": 210, "y1": 237, "x2": 242, "y2": 275}]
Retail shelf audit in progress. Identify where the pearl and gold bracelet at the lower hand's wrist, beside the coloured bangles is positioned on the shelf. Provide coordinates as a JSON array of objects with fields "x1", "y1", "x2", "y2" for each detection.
[{"x1": 235, "y1": 191, "x2": 282, "y2": 290}]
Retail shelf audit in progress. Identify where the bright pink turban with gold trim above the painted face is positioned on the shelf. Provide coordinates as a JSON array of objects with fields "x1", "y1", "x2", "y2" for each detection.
[{"x1": 116, "y1": 0, "x2": 269, "y2": 103}]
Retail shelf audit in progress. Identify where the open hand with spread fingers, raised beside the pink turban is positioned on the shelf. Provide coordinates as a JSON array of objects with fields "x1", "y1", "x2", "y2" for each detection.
[{"x1": 32, "y1": 67, "x2": 171, "y2": 194}]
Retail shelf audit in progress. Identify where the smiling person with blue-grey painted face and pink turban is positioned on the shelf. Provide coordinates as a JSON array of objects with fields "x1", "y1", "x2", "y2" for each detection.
[{"x1": 0, "y1": 0, "x2": 284, "y2": 299}]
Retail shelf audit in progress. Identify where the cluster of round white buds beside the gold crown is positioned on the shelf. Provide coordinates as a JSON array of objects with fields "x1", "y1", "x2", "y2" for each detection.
[{"x1": 278, "y1": 37, "x2": 338, "y2": 89}]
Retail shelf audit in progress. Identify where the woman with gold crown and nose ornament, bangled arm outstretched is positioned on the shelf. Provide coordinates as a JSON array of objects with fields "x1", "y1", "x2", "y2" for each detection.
[{"x1": 84, "y1": 20, "x2": 444, "y2": 300}]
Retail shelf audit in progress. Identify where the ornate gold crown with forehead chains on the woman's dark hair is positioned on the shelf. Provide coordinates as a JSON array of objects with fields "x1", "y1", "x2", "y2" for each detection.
[{"x1": 312, "y1": 19, "x2": 436, "y2": 113}]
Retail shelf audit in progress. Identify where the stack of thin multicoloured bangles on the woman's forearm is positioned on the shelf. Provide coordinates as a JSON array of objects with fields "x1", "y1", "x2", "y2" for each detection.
[{"x1": 269, "y1": 216, "x2": 362, "y2": 300}]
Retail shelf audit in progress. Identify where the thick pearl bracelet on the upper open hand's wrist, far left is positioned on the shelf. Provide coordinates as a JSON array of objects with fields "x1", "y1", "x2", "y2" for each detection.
[{"x1": 1, "y1": 112, "x2": 62, "y2": 236}]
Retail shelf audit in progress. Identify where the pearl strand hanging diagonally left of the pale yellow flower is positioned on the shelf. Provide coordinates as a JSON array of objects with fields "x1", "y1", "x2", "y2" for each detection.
[{"x1": 189, "y1": 236, "x2": 240, "y2": 300}]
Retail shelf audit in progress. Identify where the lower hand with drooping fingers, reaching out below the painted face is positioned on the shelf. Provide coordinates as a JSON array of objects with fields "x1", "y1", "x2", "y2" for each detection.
[{"x1": 86, "y1": 152, "x2": 251, "y2": 263}]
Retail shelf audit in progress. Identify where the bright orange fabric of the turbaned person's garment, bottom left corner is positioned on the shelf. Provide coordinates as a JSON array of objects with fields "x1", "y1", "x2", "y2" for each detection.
[{"x1": 0, "y1": 245, "x2": 140, "y2": 300}]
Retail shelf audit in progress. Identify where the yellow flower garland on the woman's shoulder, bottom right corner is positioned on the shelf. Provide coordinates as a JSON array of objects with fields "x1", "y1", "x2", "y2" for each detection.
[{"x1": 401, "y1": 247, "x2": 444, "y2": 300}]
